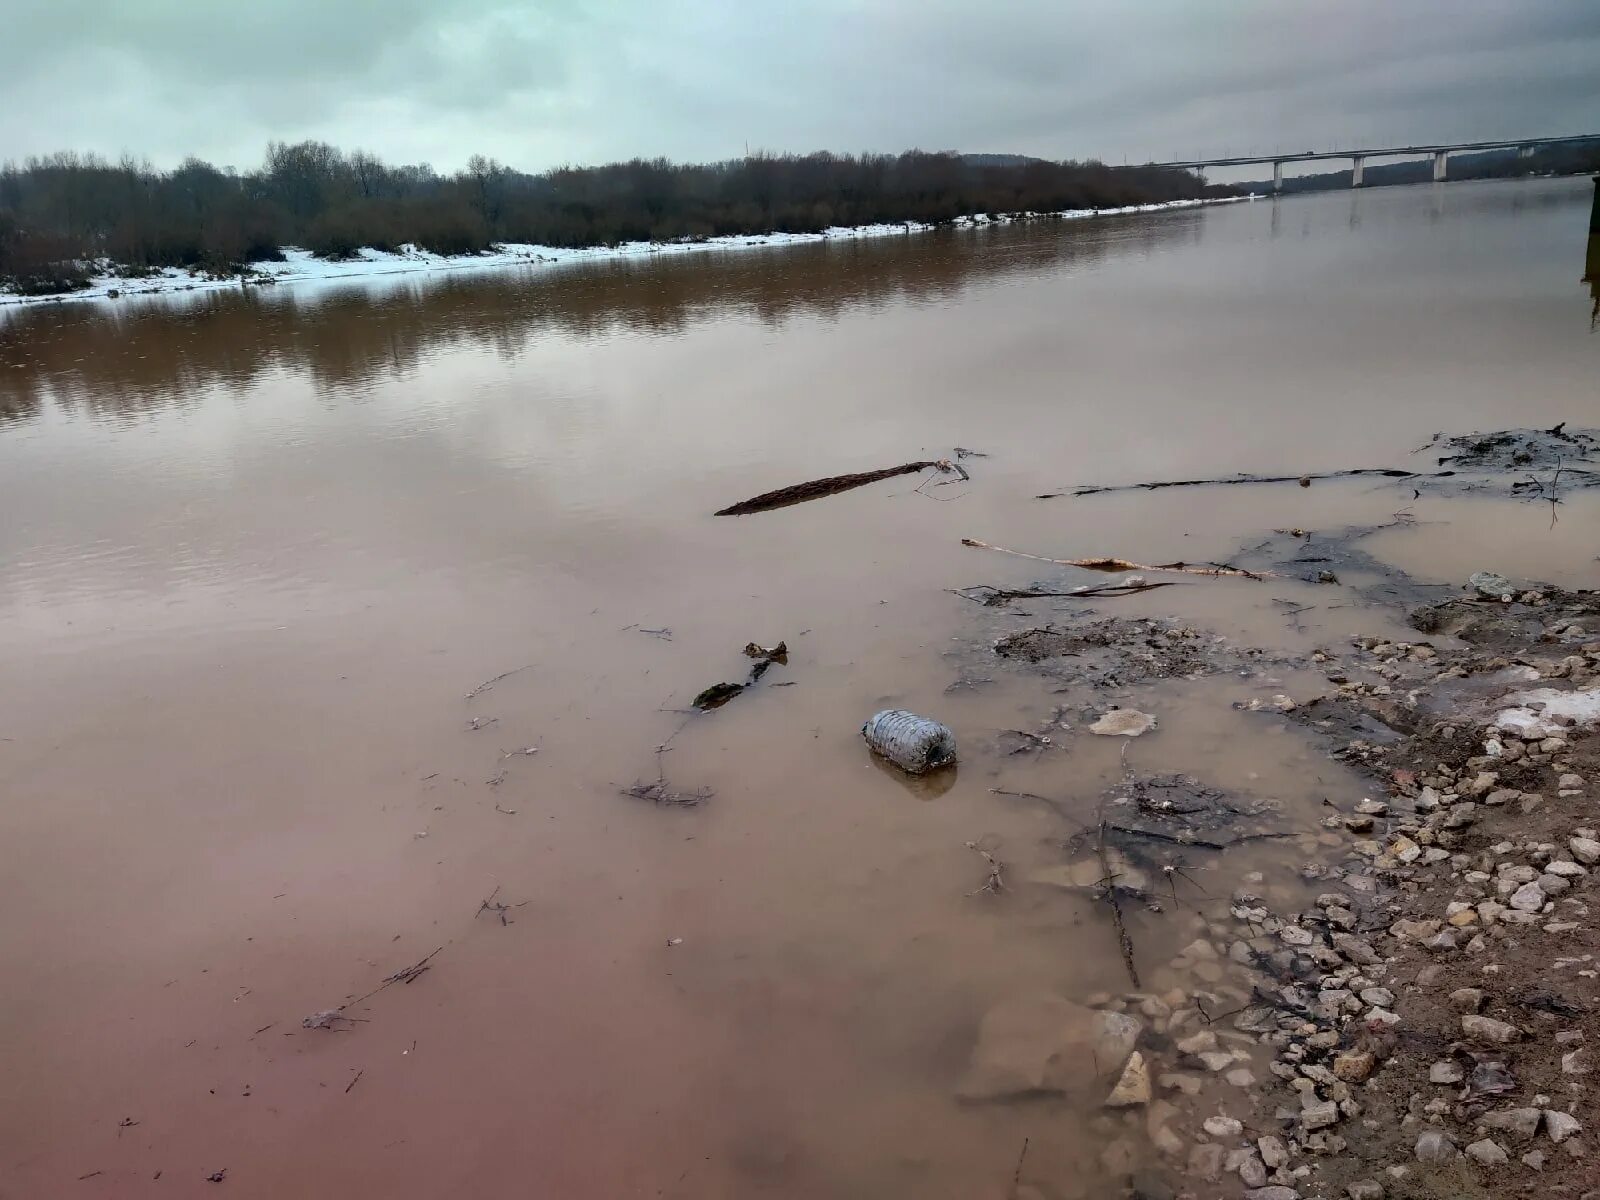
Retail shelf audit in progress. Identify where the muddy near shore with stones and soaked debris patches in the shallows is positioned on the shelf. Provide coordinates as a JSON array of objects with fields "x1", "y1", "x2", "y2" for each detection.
[{"x1": 940, "y1": 430, "x2": 1600, "y2": 1200}]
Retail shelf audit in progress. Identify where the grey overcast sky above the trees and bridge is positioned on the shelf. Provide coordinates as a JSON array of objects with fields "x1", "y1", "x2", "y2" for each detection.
[{"x1": 0, "y1": 0, "x2": 1600, "y2": 170}]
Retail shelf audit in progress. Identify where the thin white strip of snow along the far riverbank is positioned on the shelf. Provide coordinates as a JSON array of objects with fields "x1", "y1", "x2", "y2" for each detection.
[{"x1": 0, "y1": 197, "x2": 1248, "y2": 306}]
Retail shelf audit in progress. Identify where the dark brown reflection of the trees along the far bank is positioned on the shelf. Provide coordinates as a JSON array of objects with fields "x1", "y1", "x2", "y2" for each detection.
[{"x1": 0, "y1": 211, "x2": 1202, "y2": 421}]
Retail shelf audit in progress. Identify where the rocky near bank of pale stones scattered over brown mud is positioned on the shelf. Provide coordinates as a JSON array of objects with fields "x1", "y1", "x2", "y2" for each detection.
[{"x1": 958, "y1": 483, "x2": 1600, "y2": 1200}]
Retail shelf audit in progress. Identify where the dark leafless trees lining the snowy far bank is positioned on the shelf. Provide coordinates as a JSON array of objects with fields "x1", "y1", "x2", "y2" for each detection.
[{"x1": 0, "y1": 141, "x2": 1232, "y2": 293}]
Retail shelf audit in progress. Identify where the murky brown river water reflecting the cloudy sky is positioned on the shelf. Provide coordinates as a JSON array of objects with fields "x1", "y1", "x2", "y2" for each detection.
[{"x1": 9, "y1": 181, "x2": 1600, "y2": 1200}]
